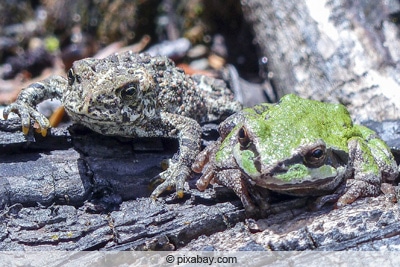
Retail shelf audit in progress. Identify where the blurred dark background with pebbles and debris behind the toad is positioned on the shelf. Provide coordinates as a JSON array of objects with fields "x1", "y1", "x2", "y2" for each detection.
[{"x1": 0, "y1": 0, "x2": 268, "y2": 111}]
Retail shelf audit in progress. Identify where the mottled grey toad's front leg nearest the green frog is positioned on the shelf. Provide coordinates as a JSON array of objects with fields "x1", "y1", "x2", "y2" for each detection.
[{"x1": 151, "y1": 112, "x2": 201, "y2": 198}]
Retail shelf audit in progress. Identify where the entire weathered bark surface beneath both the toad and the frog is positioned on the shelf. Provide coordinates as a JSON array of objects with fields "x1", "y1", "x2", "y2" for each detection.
[{"x1": 0, "y1": 120, "x2": 400, "y2": 252}]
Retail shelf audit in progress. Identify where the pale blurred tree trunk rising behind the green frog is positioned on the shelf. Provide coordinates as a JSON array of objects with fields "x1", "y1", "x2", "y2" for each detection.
[{"x1": 242, "y1": 0, "x2": 400, "y2": 121}]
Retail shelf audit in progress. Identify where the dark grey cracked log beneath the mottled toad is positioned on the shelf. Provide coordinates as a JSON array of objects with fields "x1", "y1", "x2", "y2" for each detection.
[{"x1": 0, "y1": 120, "x2": 244, "y2": 250}]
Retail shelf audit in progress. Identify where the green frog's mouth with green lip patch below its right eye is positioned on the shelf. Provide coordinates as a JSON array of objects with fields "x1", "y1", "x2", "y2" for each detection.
[{"x1": 253, "y1": 164, "x2": 345, "y2": 196}]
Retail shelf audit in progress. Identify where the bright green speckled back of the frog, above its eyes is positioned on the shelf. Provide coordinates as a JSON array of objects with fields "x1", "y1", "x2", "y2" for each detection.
[{"x1": 236, "y1": 94, "x2": 359, "y2": 155}]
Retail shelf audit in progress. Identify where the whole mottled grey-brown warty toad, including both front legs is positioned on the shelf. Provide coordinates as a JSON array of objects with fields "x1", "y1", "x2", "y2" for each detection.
[{"x1": 4, "y1": 52, "x2": 241, "y2": 197}]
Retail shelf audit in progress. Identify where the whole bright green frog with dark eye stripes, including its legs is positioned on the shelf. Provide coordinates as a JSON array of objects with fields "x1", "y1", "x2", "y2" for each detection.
[{"x1": 192, "y1": 95, "x2": 398, "y2": 216}]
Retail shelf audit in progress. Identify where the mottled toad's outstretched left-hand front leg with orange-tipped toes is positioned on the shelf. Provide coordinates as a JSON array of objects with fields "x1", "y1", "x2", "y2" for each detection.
[{"x1": 3, "y1": 76, "x2": 68, "y2": 136}]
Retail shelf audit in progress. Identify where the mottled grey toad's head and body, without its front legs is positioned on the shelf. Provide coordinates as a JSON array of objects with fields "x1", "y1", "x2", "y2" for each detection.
[{"x1": 62, "y1": 52, "x2": 241, "y2": 135}]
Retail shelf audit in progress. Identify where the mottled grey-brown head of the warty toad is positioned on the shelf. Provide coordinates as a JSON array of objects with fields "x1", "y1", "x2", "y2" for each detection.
[{"x1": 63, "y1": 53, "x2": 162, "y2": 127}]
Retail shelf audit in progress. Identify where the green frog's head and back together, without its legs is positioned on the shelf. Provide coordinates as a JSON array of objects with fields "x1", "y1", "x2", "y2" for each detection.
[{"x1": 217, "y1": 95, "x2": 354, "y2": 195}]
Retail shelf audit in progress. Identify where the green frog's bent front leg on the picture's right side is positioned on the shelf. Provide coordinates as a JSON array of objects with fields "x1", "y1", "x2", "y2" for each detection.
[{"x1": 336, "y1": 137, "x2": 382, "y2": 207}]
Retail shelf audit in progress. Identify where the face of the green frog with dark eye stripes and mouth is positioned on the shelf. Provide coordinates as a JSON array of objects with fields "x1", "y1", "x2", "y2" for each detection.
[{"x1": 233, "y1": 128, "x2": 347, "y2": 195}]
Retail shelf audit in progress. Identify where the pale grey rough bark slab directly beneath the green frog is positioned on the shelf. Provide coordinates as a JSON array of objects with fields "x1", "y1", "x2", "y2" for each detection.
[{"x1": 182, "y1": 196, "x2": 400, "y2": 251}]
